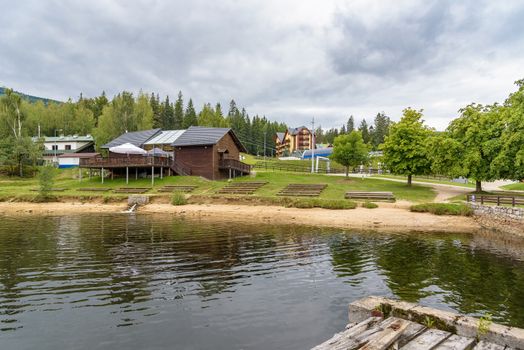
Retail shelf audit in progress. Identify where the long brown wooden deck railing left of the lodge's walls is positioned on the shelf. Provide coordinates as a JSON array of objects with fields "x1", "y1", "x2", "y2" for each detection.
[{"x1": 80, "y1": 156, "x2": 172, "y2": 168}]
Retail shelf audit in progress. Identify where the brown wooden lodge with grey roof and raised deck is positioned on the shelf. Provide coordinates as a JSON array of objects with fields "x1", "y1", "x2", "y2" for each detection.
[{"x1": 79, "y1": 126, "x2": 251, "y2": 181}]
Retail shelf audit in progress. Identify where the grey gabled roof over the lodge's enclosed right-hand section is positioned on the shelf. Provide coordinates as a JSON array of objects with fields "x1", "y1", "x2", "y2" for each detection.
[{"x1": 172, "y1": 126, "x2": 246, "y2": 152}]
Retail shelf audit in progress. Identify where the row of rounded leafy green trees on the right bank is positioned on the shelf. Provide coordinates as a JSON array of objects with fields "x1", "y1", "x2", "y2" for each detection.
[{"x1": 333, "y1": 79, "x2": 524, "y2": 192}]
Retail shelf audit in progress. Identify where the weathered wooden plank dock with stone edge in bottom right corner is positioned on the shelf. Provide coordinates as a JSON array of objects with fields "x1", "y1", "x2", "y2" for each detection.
[{"x1": 313, "y1": 297, "x2": 524, "y2": 350}]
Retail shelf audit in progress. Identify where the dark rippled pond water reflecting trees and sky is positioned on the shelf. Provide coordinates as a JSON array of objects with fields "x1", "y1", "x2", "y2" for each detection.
[{"x1": 0, "y1": 214, "x2": 524, "y2": 349}]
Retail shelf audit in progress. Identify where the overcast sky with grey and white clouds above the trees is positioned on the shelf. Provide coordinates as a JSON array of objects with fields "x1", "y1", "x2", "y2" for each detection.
[{"x1": 0, "y1": 0, "x2": 524, "y2": 129}]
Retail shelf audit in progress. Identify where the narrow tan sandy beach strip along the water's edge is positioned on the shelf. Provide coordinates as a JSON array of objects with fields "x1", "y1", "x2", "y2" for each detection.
[{"x1": 0, "y1": 202, "x2": 481, "y2": 233}]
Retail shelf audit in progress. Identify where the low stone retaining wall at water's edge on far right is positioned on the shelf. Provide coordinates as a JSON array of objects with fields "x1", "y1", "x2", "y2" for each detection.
[{"x1": 469, "y1": 203, "x2": 524, "y2": 236}]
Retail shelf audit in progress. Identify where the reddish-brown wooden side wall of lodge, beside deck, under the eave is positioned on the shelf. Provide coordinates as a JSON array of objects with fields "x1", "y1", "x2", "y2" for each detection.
[{"x1": 175, "y1": 146, "x2": 214, "y2": 180}]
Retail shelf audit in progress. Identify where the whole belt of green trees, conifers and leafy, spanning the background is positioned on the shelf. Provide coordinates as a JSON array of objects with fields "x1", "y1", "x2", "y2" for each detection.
[{"x1": 0, "y1": 80, "x2": 524, "y2": 190}]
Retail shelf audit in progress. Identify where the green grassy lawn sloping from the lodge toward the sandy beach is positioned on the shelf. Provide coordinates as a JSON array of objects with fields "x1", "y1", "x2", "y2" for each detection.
[{"x1": 0, "y1": 169, "x2": 435, "y2": 202}]
